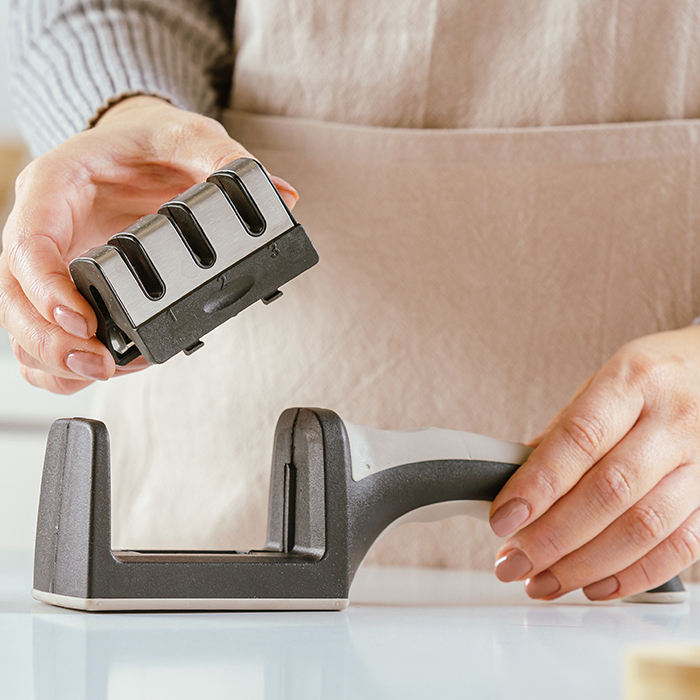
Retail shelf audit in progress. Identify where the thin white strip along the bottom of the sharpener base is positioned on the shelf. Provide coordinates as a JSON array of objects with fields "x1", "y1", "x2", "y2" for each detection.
[{"x1": 32, "y1": 588, "x2": 348, "y2": 612}]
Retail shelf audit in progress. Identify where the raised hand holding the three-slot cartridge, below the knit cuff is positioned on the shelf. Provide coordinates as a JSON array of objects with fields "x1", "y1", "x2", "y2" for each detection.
[{"x1": 0, "y1": 96, "x2": 298, "y2": 394}]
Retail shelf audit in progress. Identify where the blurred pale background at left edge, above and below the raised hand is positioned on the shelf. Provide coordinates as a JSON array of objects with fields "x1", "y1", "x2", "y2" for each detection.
[{"x1": 0, "y1": 0, "x2": 90, "y2": 550}]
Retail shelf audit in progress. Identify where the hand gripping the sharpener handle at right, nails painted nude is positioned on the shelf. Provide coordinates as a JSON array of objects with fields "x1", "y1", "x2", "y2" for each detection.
[{"x1": 491, "y1": 326, "x2": 700, "y2": 600}]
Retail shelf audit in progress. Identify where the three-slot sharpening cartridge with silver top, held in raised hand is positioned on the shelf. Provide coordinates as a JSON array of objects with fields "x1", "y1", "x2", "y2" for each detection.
[{"x1": 70, "y1": 158, "x2": 318, "y2": 366}]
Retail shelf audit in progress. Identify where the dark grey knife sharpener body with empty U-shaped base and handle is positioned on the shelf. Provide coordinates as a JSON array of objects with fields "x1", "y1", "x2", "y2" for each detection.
[{"x1": 32, "y1": 408, "x2": 686, "y2": 611}]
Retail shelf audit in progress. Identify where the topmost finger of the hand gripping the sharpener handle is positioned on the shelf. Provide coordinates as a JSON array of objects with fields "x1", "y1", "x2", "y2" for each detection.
[{"x1": 491, "y1": 369, "x2": 644, "y2": 537}]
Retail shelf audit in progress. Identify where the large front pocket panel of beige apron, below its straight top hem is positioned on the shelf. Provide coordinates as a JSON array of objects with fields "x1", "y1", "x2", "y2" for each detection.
[{"x1": 95, "y1": 113, "x2": 700, "y2": 568}]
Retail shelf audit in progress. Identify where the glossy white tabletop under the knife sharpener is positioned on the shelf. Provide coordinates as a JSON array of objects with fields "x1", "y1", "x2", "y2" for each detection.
[{"x1": 0, "y1": 553, "x2": 700, "y2": 700}]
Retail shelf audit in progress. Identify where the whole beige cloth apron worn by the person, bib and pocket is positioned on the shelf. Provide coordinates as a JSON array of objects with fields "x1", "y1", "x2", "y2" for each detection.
[{"x1": 91, "y1": 0, "x2": 700, "y2": 580}]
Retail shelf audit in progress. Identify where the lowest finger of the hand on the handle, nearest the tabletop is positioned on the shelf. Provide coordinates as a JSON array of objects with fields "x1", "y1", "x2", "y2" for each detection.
[{"x1": 583, "y1": 510, "x2": 700, "y2": 600}]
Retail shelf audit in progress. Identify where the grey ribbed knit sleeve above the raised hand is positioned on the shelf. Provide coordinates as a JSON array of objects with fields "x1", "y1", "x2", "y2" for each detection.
[{"x1": 10, "y1": 0, "x2": 232, "y2": 155}]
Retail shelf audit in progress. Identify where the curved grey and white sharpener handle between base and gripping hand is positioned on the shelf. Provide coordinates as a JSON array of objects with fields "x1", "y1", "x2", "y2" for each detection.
[{"x1": 343, "y1": 421, "x2": 531, "y2": 566}]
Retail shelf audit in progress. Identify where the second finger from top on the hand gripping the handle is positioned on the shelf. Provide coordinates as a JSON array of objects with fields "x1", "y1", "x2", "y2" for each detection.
[{"x1": 496, "y1": 417, "x2": 688, "y2": 581}]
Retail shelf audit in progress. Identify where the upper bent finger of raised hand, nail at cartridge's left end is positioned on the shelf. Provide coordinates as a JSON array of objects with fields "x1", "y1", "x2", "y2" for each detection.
[{"x1": 2, "y1": 158, "x2": 97, "y2": 339}]
